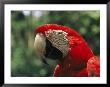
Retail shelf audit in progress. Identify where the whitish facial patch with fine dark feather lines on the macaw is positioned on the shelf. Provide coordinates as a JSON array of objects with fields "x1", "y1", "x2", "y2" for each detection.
[{"x1": 45, "y1": 29, "x2": 69, "y2": 57}]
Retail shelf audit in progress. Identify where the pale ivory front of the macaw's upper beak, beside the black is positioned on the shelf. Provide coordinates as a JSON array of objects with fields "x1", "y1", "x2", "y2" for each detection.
[{"x1": 34, "y1": 33, "x2": 46, "y2": 58}]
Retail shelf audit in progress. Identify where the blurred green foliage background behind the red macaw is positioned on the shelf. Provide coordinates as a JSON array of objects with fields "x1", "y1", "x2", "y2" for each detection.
[{"x1": 11, "y1": 10, "x2": 100, "y2": 77}]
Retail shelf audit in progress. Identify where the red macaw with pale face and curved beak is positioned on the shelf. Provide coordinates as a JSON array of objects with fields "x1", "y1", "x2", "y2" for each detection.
[{"x1": 33, "y1": 24, "x2": 100, "y2": 77}]
